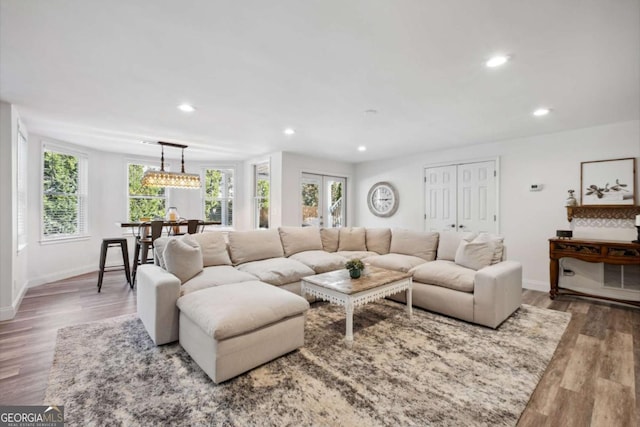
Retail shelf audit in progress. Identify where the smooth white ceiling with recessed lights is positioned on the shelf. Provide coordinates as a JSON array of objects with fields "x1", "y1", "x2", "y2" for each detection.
[{"x1": 0, "y1": 0, "x2": 640, "y2": 162}]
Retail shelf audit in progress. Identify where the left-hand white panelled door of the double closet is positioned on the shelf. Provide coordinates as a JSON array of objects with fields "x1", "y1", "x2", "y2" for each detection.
[{"x1": 425, "y1": 165, "x2": 457, "y2": 231}]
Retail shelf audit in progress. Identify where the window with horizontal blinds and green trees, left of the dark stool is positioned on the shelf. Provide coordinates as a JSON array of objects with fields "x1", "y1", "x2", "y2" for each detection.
[{"x1": 42, "y1": 144, "x2": 88, "y2": 240}]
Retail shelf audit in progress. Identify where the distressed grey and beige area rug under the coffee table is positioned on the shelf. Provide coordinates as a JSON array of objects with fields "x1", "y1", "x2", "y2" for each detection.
[{"x1": 43, "y1": 301, "x2": 570, "y2": 426}]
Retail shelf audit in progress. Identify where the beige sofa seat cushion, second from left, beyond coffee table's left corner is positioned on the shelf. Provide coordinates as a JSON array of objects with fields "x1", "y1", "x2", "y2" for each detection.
[{"x1": 237, "y1": 258, "x2": 316, "y2": 286}]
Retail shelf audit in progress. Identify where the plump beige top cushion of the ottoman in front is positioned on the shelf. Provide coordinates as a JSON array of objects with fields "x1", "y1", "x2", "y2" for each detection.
[{"x1": 177, "y1": 281, "x2": 309, "y2": 340}]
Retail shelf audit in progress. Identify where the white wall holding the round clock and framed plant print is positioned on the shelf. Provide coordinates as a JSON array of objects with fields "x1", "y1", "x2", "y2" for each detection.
[{"x1": 355, "y1": 121, "x2": 640, "y2": 290}]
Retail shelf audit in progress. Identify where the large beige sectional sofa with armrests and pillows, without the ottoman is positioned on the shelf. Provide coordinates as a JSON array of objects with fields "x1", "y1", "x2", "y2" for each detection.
[{"x1": 137, "y1": 227, "x2": 522, "y2": 345}]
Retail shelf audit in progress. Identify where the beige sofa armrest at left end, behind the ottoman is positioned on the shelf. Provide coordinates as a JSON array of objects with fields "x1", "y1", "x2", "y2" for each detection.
[{"x1": 136, "y1": 264, "x2": 180, "y2": 345}]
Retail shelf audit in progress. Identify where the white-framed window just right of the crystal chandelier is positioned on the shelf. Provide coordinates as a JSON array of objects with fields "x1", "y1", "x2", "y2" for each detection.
[{"x1": 203, "y1": 169, "x2": 233, "y2": 227}]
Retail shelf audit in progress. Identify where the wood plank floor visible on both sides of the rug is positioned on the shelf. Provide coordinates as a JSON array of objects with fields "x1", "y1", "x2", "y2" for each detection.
[{"x1": 0, "y1": 273, "x2": 640, "y2": 427}]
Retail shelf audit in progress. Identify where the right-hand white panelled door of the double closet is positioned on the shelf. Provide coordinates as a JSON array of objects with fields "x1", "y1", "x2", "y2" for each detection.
[{"x1": 458, "y1": 161, "x2": 497, "y2": 233}]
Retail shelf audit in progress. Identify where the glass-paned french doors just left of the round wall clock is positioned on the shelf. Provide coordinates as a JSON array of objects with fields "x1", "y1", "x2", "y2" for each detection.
[{"x1": 300, "y1": 173, "x2": 347, "y2": 228}]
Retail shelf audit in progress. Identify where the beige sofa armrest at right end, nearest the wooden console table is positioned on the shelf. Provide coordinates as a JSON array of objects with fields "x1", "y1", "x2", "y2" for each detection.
[{"x1": 473, "y1": 261, "x2": 522, "y2": 328}]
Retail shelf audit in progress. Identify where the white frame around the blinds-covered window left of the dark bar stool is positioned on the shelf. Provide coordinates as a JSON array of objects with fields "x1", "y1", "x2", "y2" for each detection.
[{"x1": 40, "y1": 140, "x2": 91, "y2": 244}]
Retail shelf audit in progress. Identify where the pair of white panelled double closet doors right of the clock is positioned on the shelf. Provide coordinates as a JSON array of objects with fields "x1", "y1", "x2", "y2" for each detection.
[{"x1": 424, "y1": 161, "x2": 498, "y2": 233}]
